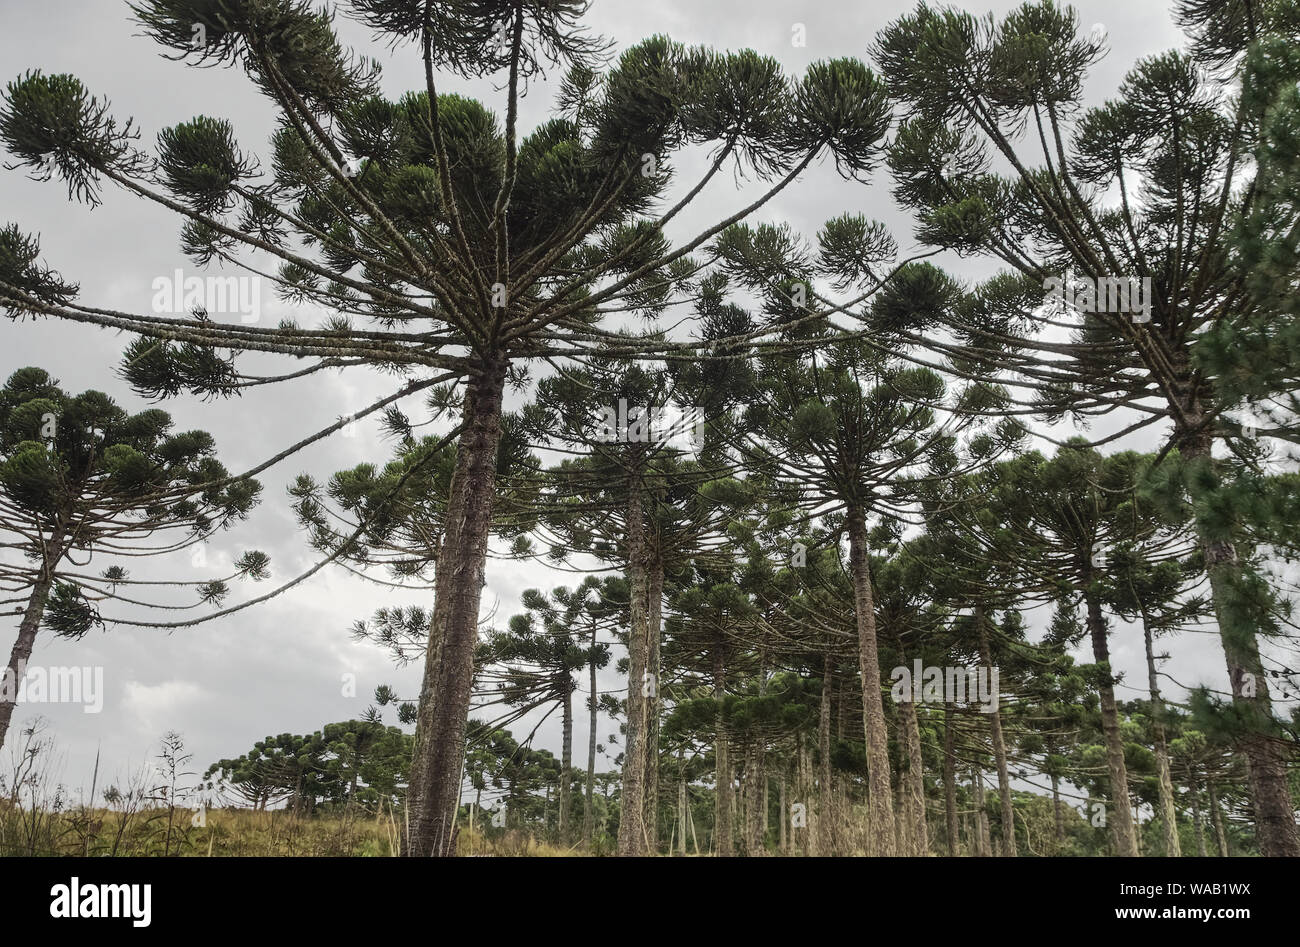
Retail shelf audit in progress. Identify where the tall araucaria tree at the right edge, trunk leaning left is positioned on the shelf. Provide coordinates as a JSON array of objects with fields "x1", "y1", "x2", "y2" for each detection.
[{"x1": 872, "y1": 0, "x2": 1300, "y2": 856}]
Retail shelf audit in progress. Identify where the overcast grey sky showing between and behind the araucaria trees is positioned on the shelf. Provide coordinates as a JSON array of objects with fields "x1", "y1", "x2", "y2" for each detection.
[{"x1": 0, "y1": 0, "x2": 1258, "y2": 811}]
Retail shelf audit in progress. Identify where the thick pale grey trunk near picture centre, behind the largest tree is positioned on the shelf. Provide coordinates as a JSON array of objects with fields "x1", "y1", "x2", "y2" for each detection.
[{"x1": 619, "y1": 474, "x2": 658, "y2": 855}]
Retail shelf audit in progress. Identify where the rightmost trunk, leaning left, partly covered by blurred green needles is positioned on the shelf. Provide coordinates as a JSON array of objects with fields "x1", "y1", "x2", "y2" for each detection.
[{"x1": 1179, "y1": 426, "x2": 1300, "y2": 857}]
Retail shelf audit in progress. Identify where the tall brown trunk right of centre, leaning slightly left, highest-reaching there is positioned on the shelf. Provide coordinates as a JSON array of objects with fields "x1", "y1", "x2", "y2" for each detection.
[{"x1": 848, "y1": 506, "x2": 894, "y2": 857}]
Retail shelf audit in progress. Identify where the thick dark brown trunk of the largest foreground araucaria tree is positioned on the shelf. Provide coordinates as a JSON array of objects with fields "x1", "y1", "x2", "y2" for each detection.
[{"x1": 404, "y1": 359, "x2": 507, "y2": 857}]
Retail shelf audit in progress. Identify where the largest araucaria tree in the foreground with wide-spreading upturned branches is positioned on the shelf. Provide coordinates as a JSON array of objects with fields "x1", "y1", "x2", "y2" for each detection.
[{"x1": 0, "y1": 0, "x2": 887, "y2": 855}]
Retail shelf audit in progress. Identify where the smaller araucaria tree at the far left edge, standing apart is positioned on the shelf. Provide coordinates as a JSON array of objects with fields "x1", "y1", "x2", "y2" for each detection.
[{"x1": 0, "y1": 368, "x2": 268, "y2": 745}]
